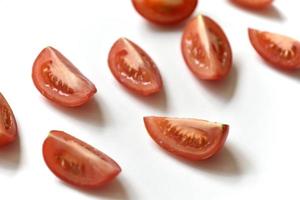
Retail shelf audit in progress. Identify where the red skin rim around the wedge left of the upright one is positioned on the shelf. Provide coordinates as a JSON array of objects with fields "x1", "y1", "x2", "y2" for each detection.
[{"x1": 108, "y1": 38, "x2": 163, "y2": 97}]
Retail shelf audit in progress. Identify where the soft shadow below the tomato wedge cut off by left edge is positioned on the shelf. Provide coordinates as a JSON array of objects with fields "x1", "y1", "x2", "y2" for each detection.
[{"x1": 0, "y1": 135, "x2": 21, "y2": 171}]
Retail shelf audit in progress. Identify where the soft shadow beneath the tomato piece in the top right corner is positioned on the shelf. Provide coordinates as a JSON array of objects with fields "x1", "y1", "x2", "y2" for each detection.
[{"x1": 229, "y1": 0, "x2": 285, "y2": 22}]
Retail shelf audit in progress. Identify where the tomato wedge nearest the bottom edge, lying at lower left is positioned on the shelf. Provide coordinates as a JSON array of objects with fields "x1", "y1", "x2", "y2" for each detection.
[{"x1": 43, "y1": 131, "x2": 121, "y2": 188}]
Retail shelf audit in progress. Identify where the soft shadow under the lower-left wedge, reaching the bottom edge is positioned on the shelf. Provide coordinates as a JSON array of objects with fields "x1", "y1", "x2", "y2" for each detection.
[{"x1": 60, "y1": 179, "x2": 129, "y2": 200}]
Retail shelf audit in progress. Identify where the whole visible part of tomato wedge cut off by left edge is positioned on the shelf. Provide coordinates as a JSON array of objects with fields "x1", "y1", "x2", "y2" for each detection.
[{"x1": 0, "y1": 93, "x2": 17, "y2": 147}]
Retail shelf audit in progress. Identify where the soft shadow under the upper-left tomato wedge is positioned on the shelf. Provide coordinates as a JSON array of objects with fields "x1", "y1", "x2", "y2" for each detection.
[{"x1": 45, "y1": 97, "x2": 105, "y2": 127}]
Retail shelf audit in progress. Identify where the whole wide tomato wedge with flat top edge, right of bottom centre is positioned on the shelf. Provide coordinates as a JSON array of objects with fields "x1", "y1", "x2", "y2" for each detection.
[{"x1": 144, "y1": 116, "x2": 229, "y2": 160}]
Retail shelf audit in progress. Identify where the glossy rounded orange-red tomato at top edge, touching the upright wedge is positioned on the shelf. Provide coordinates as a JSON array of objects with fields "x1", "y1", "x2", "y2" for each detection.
[{"x1": 132, "y1": 0, "x2": 198, "y2": 25}]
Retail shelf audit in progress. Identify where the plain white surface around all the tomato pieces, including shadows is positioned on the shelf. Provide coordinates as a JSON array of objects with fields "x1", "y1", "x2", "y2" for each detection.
[{"x1": 0, "y1": 0, "x2": 300, "y2": 200}]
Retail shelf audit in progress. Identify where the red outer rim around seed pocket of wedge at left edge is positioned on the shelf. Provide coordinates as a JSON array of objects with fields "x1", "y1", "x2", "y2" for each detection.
[{"x1": 0, "y1": 93, "x2": 18, "y2": 147}]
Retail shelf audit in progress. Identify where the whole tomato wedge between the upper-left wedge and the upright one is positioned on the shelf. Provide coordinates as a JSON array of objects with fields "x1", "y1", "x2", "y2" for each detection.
[{"x1": 108, "y1": 38, "x2": 162, "y2": 96}]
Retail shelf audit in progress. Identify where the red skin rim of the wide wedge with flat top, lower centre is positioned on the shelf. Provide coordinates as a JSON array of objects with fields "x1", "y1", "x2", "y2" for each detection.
[{"x1": 144, "y1": 116, "x2": 229, "y2": 161}]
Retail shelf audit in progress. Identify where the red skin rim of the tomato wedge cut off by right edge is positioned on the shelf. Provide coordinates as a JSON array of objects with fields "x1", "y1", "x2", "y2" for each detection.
[{"x1": 248, "y1": 28, "x2": 300, "y2": 70}]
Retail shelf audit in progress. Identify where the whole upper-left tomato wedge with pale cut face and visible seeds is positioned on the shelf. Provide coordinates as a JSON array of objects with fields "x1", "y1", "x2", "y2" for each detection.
[{"x1": 32, "y1": 47, "x2": 97, "y2": 107}]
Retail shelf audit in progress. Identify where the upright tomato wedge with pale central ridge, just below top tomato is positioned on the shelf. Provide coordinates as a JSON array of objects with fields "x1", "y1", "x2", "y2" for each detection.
[{"x1": 181, "y1": 15, "x2": 232, "y2": 80}]
